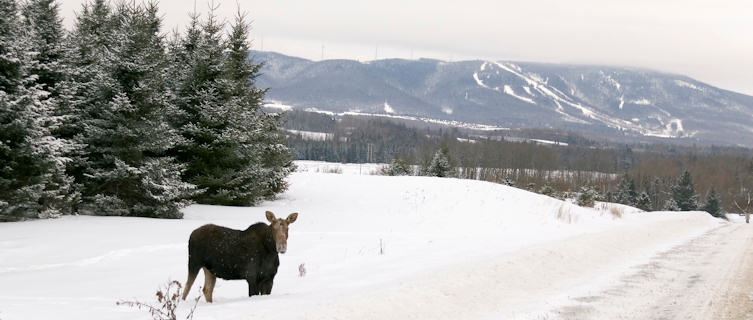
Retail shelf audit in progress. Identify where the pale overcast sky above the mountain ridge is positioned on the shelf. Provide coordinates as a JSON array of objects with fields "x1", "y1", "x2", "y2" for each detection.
[{"x1": 58, "y1": 0, "x2": 753, "y2": 95}]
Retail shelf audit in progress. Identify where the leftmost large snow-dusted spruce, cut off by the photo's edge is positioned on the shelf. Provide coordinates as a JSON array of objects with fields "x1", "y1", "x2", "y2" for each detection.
[{"x1": 0, "y1": 0, "x2": 71, "y2": 220}]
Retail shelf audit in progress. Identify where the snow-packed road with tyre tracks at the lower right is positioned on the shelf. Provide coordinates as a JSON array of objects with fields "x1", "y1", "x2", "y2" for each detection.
[{"x1": 551, "y1": 223, "x2": 753, "y2": 320}]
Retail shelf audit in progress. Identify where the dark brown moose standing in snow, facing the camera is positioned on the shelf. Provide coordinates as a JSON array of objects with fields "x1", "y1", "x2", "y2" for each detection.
[{"x1": 183, "y1": 211, "x2": 298, "y2": 302}]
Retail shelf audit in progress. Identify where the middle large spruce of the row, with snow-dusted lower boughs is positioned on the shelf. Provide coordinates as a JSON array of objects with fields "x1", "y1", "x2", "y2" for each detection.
[{"x1": 74, "y1": 3, "x2": 195, "y2": 218}]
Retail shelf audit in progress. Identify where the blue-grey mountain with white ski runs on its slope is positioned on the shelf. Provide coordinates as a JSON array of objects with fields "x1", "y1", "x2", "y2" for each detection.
[{"x1": 250, "y1": 51, "x2": 753, "y2": 147}]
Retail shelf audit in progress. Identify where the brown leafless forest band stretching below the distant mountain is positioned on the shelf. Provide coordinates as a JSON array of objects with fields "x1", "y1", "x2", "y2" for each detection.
[{"x1": 284, "y1": 111, "x2": 753, "y2": 212}]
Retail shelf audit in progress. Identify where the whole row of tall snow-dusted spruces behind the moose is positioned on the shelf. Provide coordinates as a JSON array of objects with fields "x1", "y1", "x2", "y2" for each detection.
[{"x1": 0, "y1": 0, "x2": 293, "y2": 220}]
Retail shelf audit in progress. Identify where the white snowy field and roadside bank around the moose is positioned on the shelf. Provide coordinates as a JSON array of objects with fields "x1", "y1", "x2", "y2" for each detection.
[{"x1": 0, "y1": 163, "x2": 726, "y2": 320}]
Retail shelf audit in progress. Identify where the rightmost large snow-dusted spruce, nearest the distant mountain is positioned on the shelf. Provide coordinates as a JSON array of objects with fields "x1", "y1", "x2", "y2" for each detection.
[{"x1": 170, "y1": 12, "x2": 293, "y2": 205}]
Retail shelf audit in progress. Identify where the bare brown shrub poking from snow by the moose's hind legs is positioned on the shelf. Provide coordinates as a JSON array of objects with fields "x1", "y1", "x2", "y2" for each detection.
[{"x1": 115, "y1": 280, "x2": 201, "y2": 320}]
